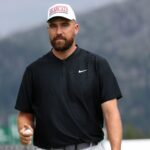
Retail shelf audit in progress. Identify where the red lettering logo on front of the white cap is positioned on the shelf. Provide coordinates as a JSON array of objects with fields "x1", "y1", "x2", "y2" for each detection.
[{"x1": 49, "y1": 6, "x2": 68, "y2": 16}]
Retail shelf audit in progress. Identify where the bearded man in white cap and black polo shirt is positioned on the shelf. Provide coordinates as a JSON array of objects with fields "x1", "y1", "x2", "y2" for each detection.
[{"x1": 15, "y1": 4, "x2": 122, "y2": 150}]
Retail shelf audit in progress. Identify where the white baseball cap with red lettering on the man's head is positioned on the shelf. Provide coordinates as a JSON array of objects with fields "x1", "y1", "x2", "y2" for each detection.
[{"x1": 47, "y1": 4, "x2": 76, "y2": 21}]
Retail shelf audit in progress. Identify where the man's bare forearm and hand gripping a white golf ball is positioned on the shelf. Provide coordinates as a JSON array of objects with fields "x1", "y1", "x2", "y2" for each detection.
[{"x1": 17, "y1": 112, "x2": 34, "y2": 144}]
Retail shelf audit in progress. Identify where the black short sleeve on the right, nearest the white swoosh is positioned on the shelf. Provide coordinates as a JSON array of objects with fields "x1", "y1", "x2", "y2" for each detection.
[{"x1": 97, "y1": 58, "x2": 122, "y2": 103}]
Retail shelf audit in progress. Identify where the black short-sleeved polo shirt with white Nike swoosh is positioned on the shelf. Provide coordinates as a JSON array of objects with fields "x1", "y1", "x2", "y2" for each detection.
[{"x1": 15, "y1": 48, "x2": 121, "y2": 148}]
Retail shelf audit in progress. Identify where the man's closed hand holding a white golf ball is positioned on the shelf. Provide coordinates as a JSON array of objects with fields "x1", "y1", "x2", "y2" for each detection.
[{"x1": 19, "y1": 125, "x2": 33, "y2": 145}]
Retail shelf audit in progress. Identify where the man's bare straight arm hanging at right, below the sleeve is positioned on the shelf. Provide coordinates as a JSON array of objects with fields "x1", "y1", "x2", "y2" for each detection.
[{"x1": 101, "y1": 99, "x2": 122, "y2": 150}]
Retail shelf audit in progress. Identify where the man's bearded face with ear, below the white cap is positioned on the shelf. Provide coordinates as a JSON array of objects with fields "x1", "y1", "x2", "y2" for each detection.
[{"x1": 48, "y1": 17, "x2": 79, "y2": 51}]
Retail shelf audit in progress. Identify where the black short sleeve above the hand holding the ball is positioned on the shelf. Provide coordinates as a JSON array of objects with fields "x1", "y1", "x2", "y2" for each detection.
[{"x1": 15, "y1": 68, "x2": 33, "y2": 113}]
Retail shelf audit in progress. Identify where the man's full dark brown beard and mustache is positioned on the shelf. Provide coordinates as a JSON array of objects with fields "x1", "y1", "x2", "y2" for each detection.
[{"x1": 50, "y1": 35, "x2": 74, "y2": 52}]
